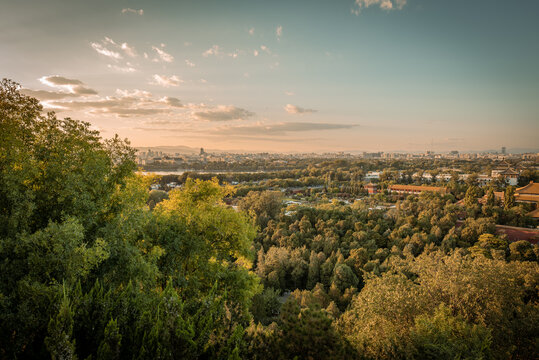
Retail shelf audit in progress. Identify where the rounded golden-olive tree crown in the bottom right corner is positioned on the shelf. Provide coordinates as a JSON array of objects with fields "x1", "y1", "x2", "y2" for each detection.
[{"x1": 338, "y1": 252, "x2": 539, "y2": 359}]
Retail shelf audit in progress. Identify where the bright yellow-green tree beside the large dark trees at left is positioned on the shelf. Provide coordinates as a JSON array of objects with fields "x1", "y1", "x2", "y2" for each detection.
[{"x1": 148, "y1": 179, "x2": 260, "y2": 315}]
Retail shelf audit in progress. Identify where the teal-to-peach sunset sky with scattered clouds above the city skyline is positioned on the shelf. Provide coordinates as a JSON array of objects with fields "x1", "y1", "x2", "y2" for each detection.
[{"x1": 0, "y1": 0, "x2": 539, "y2": 152}]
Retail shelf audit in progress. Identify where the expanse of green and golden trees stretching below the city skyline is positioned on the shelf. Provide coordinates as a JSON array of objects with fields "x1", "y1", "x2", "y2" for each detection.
[{"x1": 0, "y1": 80, "x2": 539, "y2": 359}]
